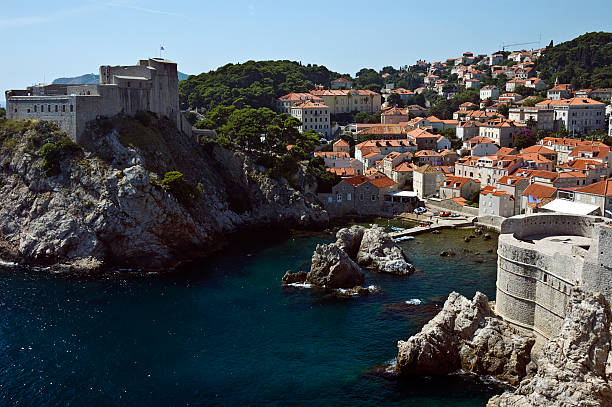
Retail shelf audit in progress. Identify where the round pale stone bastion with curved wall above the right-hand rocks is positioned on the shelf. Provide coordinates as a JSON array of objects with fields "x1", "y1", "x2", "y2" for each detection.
[{"x1": 495, "y1": 214, "x2": 612, "y2": 340}]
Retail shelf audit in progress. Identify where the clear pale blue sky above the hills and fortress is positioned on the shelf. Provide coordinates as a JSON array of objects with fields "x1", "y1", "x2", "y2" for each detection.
[{"x1": 0, "y1": 0, "x2": 612, "y2": 103}]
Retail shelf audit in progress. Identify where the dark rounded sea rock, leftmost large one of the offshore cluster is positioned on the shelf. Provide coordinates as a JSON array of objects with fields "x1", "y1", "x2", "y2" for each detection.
[{"x1": 307, "y1": 243, "x2": 365, "y2": 288}]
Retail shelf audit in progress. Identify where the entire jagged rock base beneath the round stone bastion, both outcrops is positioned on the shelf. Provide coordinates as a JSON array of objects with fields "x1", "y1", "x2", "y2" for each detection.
[{"x1": 397, "y1": 290, "x2": 612, "y2": 407}]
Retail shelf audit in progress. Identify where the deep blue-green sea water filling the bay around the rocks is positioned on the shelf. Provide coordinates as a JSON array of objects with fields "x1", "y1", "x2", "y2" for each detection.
[{"x1": 0, "y1": 231, "x2": 501, "y2": 406}]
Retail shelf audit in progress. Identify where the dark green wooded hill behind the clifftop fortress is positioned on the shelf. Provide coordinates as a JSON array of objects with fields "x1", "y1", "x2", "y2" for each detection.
[{"x1": 179, "y1": 60, "x2": 349, "y2": 110}]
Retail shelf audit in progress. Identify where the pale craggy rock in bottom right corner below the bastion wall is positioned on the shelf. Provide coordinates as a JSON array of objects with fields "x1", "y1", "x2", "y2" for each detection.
[{"x1": 487, "y1": 291, "x2": 612, "y2": 407}]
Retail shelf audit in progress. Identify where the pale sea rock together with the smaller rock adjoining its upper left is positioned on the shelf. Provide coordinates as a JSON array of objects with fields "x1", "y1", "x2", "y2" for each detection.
[{"x1": 336, "y1": 225, "x2": 414, "y2": 275}]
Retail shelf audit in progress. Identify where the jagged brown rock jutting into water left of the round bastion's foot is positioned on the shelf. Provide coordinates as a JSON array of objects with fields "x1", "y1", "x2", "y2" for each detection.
[{"x1": 397, "y1": 292, "x2": 534, "y2": 383}]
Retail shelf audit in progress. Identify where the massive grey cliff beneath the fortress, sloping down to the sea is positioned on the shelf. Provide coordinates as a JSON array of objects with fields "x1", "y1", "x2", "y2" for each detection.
[{"x1": 0, "y1": 115, "x2": 328, "y2": 270}]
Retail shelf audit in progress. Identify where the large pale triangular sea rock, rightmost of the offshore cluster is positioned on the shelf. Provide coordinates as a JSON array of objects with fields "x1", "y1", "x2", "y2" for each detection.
[{"x1": 356, "y1": 225, "x2": 414, "y2": 275}]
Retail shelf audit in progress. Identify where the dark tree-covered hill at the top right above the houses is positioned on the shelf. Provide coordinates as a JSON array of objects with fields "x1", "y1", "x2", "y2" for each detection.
[{"x1": 535, "y1": 32, "x2": 612, "y2": 89}]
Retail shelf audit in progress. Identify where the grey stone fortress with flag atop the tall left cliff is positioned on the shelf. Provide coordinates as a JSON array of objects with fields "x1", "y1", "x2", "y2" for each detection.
[{"x1": 6, "y1": 58, "x2": 183, "y2": 142}]
